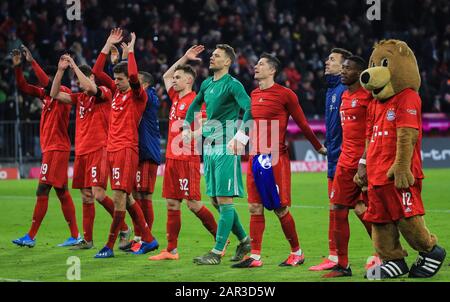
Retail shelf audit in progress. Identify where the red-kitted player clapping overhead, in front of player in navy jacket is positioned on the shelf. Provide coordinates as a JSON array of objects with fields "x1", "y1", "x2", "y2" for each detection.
[{"x1": 93, "y1": 29, "x2": 157, "y2": 258}]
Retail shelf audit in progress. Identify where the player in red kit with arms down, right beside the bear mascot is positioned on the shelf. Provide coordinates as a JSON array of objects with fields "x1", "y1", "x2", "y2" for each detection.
[{"x1": 323, "y1": 56, "x2": 379, "y2": 278}]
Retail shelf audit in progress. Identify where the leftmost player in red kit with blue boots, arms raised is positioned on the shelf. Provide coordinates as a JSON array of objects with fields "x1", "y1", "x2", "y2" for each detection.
[{"x1": 12, "y1": 45, "x2": 81, "y2": 247}]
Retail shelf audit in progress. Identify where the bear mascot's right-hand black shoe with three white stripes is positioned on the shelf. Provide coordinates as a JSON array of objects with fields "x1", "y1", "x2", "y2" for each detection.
[{"x1": 408, "y1": 245, "x2": 446, "y2": 278}]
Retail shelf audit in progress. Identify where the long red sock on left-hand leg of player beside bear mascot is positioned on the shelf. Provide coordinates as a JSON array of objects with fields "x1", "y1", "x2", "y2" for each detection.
[{"x1": 332, "y1": 208, "x2": 350, "y2": 268}]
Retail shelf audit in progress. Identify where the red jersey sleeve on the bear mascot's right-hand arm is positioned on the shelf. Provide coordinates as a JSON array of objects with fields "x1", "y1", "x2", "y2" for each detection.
[{"x1": 396, "y1": 91, "x2": 422, "y2": 129}]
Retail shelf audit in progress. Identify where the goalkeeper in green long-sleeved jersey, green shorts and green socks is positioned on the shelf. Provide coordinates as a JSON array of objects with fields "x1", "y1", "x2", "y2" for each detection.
[{"x1": 182, "y1": 44, "x2": 251, "y2": 265}]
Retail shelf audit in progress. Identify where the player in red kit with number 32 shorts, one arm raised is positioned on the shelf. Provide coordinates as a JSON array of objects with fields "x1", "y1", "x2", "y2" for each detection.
[{"x1": 149, "y1": 45, "x2": 217, "y2": 260}]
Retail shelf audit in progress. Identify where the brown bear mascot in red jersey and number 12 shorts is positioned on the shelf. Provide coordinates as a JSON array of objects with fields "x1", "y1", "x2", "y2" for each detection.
[{"x1": 354, "y1": 40, "x2": 446, "y2": 279}]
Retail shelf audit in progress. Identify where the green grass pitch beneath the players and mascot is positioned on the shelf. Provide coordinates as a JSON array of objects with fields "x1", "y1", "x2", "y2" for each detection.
[{"x1": 0, "y1": 169, "x2": 450, "y2": 282}]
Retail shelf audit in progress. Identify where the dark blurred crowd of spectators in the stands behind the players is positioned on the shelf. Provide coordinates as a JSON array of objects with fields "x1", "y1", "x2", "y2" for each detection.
[{"x1": 0, "y1": 0, "x2": 450, "y2": 120}]
